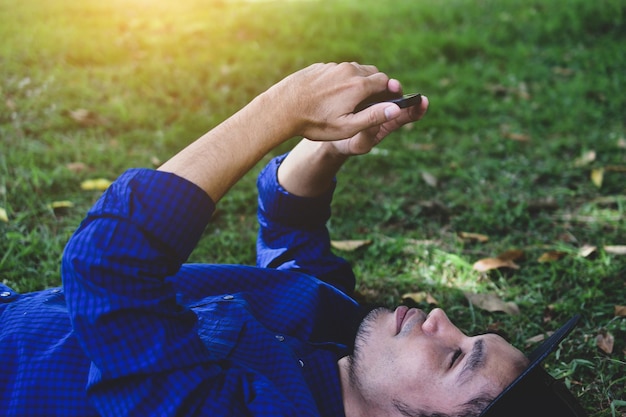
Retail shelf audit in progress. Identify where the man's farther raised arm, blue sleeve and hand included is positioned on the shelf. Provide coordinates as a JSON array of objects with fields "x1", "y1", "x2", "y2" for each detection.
[{"x1": 252, "y1": 80, "x2": 428, "y2": 294}]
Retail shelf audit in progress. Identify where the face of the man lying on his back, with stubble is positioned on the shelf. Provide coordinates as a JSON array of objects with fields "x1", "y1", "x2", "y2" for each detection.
[{"x1": 340, "y1": 306, "x2": 527, "y2": 415}]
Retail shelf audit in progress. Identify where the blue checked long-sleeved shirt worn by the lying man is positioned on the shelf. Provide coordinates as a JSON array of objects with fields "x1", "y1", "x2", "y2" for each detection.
[{"x1": 0, "y1": 157, "x2": 359, "y2": 417}]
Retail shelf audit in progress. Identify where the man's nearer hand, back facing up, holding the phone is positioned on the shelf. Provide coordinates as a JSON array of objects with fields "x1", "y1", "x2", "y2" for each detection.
[{"x1": 267, "y1": 63, "x2": 408, "y2": 141}]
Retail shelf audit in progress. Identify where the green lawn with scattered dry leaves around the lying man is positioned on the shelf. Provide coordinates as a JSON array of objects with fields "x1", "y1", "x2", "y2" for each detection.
[{"x1": 0, "y1": 0, "x2": 626, "y2": 416}]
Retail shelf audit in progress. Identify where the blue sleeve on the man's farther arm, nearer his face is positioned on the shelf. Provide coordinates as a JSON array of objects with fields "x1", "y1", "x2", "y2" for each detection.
[{"x1": 257, "y1": 154, "x2": 355, "y2": 295}]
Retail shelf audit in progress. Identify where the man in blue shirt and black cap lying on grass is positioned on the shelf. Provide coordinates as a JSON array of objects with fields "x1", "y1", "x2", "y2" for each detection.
[{"x1": 0, "y1": 63, "x2": 584, "y2": 417}]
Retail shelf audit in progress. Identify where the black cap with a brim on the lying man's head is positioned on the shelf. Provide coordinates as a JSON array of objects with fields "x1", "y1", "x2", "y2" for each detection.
[{"x1": 480, "y1": 315, "x2": 587, "y2": 417}]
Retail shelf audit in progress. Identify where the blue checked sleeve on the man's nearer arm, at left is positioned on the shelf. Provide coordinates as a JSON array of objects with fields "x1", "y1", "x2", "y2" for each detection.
[{"x1": 62, "y1": 169, "x2": 295, "y2": 416}]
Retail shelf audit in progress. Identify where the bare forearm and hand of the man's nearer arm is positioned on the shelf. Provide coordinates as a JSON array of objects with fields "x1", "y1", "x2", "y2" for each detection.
[{"x1": 159, "y1": 63, "x2": 407, "y2": 202}]
